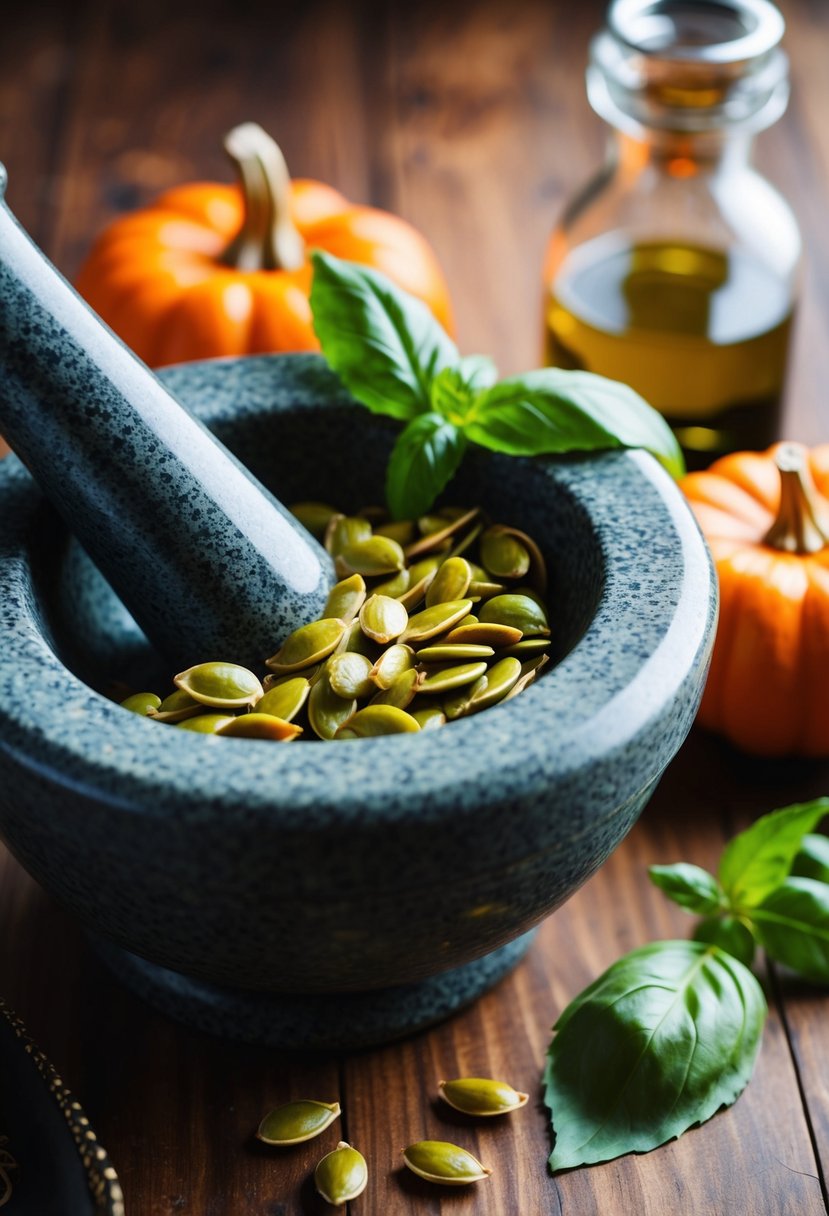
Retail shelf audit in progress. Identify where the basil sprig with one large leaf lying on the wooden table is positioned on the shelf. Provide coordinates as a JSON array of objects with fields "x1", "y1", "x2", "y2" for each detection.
[{"x1": 545, "y1": 798, "x2": 829, "y2": 1170}]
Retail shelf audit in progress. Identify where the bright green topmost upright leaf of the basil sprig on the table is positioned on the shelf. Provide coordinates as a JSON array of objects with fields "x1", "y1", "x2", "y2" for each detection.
[{"x1": 718, "y1": 798, "x2": 829, "y2": 907}]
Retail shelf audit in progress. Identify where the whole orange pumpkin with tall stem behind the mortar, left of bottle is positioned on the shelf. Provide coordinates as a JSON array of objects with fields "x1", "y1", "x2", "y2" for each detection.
[{"x1": 77, "y1": 123, "x2": 452, "y2": 367}]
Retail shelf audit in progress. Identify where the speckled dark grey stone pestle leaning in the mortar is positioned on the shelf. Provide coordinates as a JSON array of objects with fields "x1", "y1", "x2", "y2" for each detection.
[{"x1": 0, "y1": 165, "x2": 333, "y2": 669}]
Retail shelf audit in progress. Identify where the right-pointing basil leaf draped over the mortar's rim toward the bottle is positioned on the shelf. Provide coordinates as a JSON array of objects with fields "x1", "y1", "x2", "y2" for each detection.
[{"x1": 466, "y1": 367, "x2": 684, "y2": 477}]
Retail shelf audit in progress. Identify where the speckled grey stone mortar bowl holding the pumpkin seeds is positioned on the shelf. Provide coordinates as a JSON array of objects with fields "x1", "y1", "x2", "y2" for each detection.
[{"x1": 0, "y1": 355, "x2": 716, "y2": 1037}]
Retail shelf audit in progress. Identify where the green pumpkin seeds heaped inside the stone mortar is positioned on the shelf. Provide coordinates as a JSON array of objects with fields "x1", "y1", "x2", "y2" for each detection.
[{"x1": 122, "y1": 502, "x2": 551, "y2": 742}]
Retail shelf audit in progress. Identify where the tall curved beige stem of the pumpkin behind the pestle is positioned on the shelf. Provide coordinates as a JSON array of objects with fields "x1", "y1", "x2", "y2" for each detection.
[{"x1": 219, "y1": 123, "x2": 305, "y2": 270}]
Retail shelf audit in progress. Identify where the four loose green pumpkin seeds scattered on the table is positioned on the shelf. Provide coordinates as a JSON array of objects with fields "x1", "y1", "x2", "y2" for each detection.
[{"x1": 256, "y1": 1077, "x2": 528, "y2": 1207}]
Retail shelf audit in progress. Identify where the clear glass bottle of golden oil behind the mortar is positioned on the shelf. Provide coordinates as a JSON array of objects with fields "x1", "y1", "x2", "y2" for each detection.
[{"x1": 545, "y1": 0, "x2": 800, "y2": 468}]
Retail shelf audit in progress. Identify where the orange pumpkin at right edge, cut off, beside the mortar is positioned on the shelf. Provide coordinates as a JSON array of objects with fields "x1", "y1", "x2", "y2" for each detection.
[{"x1": 682, "y1": 443, "x2": 829, "y2": 756}]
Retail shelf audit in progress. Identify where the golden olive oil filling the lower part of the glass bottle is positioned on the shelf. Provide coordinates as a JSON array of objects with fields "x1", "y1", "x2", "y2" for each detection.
[{"x1": 546, "y1": 235, "x2": 793, "y2": 466}]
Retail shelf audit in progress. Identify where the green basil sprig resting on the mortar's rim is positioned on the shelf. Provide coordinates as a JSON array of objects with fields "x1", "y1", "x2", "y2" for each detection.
[{"x1": 311, "y1": 250, "x2": 684, "y2": 518}]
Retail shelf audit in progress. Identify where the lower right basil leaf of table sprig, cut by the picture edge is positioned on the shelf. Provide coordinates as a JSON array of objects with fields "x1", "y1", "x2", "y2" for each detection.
[{"x1": 751, "y1": 878, "x2": 829, "y2": 984}]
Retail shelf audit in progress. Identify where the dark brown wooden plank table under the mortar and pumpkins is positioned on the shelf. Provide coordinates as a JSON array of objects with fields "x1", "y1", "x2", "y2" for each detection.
[{"x1": 0, "y1": 0, "x2": 829, "y2": 1216}]
